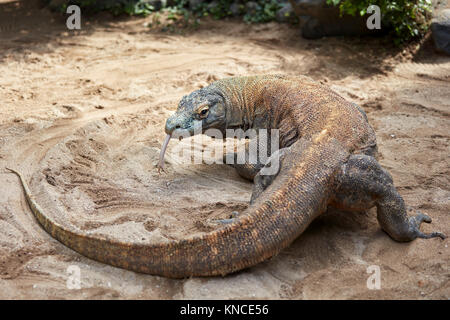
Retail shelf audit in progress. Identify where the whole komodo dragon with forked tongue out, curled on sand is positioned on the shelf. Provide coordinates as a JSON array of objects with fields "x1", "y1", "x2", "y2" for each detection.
[{"x1": 7, "y1": 75, "x2": 445, "y2": 278}]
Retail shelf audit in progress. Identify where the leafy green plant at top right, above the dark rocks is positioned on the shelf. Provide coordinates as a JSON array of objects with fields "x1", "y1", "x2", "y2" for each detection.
[{"x1": 327, "y1": 0, "x2": 432, "y2": 44}]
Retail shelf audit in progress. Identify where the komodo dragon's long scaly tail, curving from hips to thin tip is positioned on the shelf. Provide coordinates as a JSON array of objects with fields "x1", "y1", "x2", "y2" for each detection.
[{"x1": 8, "y1": 141, "x2": 346, "y2": 278}]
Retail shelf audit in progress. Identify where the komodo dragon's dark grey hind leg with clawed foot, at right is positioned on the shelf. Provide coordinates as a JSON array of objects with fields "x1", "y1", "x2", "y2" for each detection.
[{"x1": 331, "y1": 155, "x2": 445, "y2": 241}]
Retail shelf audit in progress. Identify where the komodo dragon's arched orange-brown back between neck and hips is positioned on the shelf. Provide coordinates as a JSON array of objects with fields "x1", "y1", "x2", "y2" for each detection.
[{"x1": 213, "y1": 74, "x2": 376, "y2": 154}]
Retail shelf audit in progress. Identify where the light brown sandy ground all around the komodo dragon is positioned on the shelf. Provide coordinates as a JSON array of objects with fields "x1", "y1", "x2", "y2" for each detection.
[{"x1": 0, "y1": 0, "x2": 450, "y2": 299}]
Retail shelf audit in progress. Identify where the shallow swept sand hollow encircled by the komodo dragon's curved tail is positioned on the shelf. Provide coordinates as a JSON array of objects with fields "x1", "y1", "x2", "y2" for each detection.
[{"x1": 32, "y1": 114, "x2": 251, "y2": 243}]
